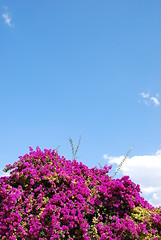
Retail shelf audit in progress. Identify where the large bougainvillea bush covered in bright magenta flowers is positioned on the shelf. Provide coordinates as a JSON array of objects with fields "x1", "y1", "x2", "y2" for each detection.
[{"x1": 0, "y1": 147, "x2": 161, "y2": 240}]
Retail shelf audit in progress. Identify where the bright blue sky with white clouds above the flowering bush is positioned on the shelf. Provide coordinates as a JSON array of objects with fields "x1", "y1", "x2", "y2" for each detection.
[{"x1": 0, "y1": 0, "x2": 161, "y2": 205}]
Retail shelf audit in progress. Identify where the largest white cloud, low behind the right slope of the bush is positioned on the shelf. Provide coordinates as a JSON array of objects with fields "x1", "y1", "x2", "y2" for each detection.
[{"x1": 104, "y1": 150, "x2": 161, "y2": 206}]
